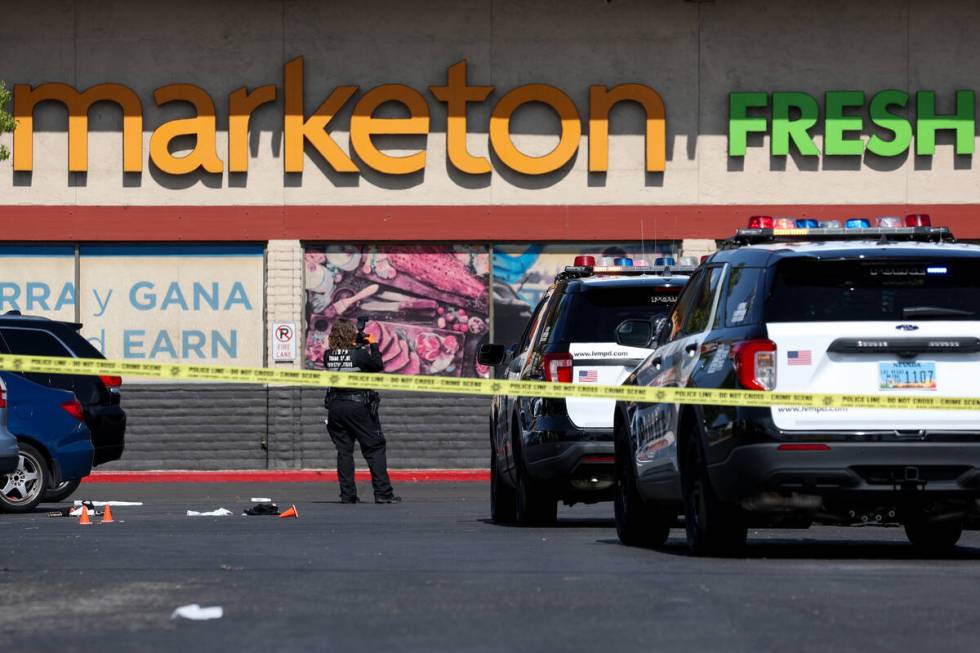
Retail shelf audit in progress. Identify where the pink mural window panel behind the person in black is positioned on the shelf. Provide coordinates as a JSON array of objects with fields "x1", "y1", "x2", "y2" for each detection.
[{"x1": 304, "y1": 245, "x2": 490, "y2": 377}]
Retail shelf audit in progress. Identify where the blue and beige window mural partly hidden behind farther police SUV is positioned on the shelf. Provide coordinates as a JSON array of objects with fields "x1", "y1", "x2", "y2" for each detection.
[{"x1": 493, "y1": 241, "x2": 679, "y2": 345}]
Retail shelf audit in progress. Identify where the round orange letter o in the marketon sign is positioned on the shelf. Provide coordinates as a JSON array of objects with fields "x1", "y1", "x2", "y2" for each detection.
[{"x1": 490, "y1": 84, "x2": 582, "y2": 175}]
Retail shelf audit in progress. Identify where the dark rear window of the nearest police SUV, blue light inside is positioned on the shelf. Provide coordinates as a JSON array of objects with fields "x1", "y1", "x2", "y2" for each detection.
[{"x1": 766, "y1": 258, "x2": 980, "y2": 322}]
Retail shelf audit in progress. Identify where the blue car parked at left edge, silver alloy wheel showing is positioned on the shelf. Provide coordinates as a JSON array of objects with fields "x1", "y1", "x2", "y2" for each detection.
[{"x1": 0, "y1": 372, "x2": 95, "y2": 512}]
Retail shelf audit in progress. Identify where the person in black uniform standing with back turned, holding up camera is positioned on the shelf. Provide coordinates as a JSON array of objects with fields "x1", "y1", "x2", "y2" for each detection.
[{"x1": 323, "y1": 320, "x2": 401, "y2": 503}]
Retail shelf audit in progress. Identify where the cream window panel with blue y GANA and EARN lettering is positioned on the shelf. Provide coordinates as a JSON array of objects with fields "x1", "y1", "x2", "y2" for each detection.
[{"x1": 80, "y1": 245, "x2": 265, "y2": 365}]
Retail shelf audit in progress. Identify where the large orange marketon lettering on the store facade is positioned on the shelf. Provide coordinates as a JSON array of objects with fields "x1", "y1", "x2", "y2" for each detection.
[{"x1": 14, "y1": 57, "x2": 666, "y2": 175}]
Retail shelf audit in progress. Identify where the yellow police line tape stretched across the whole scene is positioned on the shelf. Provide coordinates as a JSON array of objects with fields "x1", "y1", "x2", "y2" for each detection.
[{"x1": 0, "y1": 354, "x2": 980, "y2": 410}]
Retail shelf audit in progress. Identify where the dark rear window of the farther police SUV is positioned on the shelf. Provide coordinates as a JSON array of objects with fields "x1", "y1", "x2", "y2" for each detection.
[{"x1": 542, "y1": 286, "x2": 682, "y2": 342}]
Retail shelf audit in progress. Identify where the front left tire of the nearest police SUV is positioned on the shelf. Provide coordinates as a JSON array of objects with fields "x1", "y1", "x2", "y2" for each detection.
[{"x1": 613, "y1": 430, "x2": 672, "y2": 547}]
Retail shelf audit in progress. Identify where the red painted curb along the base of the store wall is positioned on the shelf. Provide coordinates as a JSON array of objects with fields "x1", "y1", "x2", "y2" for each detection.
[{"x1": 82, "y1": 469, "x2": 490, "y2": 483}]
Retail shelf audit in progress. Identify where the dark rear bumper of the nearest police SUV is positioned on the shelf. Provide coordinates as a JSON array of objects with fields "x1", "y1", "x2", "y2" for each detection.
[{"x1": 708, "y1": 442, "x2": 980, "y2": 501}]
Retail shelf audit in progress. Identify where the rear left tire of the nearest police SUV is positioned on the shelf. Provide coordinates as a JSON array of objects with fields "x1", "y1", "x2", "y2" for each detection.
[{"x1": 681, "y1": 435, "x2": 748, "y2": 556}]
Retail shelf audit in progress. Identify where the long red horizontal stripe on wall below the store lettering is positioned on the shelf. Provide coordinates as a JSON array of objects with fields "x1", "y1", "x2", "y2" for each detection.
[{"x1": 0, "y1": 204, "x2": 980, "y2": 242}]
